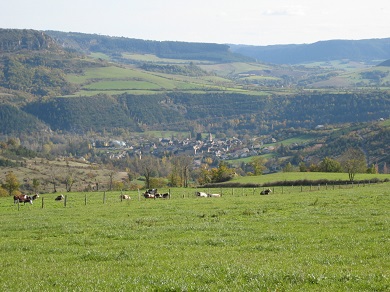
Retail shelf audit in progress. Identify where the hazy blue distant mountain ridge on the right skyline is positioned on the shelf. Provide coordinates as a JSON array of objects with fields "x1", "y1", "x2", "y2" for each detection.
[{"x1": 230, "y1": 38, "x2": 390, "y2": 64}]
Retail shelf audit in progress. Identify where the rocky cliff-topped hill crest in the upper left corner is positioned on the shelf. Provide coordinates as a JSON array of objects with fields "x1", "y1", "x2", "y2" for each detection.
[{"x1": 0, "y1": 29, "x2": 58, "y2": 53}]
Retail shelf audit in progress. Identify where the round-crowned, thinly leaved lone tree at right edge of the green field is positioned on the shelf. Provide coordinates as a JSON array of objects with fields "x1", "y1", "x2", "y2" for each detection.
[{"x1": 340, "y1": 148, "x2": 367, "y2": 181}]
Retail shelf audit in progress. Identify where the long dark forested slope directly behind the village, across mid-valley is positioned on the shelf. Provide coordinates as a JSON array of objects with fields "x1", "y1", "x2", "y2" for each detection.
[{"x1": 23, "y1": 92, "x2": 390, "y2": 133}]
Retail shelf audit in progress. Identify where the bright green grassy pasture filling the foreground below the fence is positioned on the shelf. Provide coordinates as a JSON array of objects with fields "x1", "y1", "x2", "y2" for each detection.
[{"x1": 0, "y1": 183, "x2": 390, "y2": 291}]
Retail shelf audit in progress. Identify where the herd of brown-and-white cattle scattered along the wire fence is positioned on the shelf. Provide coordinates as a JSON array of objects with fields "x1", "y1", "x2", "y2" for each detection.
[{"x1": 14, "y1": 189, "x2": 272, "y2": 204}]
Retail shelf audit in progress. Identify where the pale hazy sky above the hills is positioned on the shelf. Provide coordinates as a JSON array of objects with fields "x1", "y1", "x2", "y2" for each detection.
[{"x1": 0, "y1": 0, "x2": 390, "y2": 45}]
